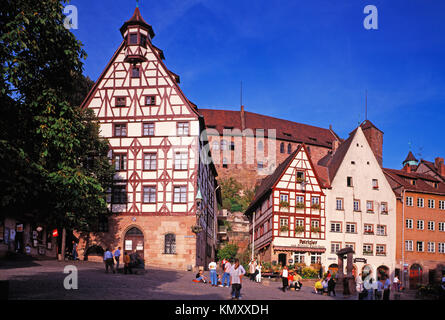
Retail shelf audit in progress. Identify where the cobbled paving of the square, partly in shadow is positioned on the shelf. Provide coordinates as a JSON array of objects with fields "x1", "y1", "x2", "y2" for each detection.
[{"x1": 0, "y1": 260, "x2": 412, "y2": 300}]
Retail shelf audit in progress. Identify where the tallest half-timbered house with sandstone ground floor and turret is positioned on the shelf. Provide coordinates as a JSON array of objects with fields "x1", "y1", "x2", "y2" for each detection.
[{"x1": 79, "y1": 8, "x2": 220, "y2": 269}]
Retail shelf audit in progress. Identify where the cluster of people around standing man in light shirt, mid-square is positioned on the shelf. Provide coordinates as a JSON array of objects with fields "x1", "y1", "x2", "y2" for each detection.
[{"x1": 193, "y1": 259, "x2": 246, "y2": 300}]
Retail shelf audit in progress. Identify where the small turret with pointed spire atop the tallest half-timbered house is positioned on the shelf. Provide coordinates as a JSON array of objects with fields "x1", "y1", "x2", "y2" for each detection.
[{"x1": 120, "y1": 6, "x2": 155, "y2": 65}]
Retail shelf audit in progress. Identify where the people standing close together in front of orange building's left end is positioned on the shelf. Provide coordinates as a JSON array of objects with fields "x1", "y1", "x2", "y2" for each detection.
[{"x1": 356, "y1": 273, "x2": 390, "y2": 300}]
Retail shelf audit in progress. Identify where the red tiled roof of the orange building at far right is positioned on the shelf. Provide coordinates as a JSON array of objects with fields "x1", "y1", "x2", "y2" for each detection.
[{"x1": 383, "y1": 168, "x2": 445, "y2": 196}]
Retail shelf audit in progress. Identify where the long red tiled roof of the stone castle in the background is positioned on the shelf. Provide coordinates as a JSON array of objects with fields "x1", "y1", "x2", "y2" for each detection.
[{"x1": 199, "y1": 109, "x2": 338, "y2": 148}]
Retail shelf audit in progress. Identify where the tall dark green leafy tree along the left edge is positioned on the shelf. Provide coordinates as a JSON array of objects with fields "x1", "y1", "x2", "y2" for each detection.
[{"x1": 0, "y1": 0, "x2": 113, "y2": 231}]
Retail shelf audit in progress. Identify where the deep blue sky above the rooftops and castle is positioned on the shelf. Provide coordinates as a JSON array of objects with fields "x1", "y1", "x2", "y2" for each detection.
[{"x1": 71, "y1": 0, "x2": 445, "y2": 168}]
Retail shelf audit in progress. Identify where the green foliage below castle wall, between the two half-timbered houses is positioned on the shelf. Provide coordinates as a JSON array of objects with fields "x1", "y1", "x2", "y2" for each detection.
[{"x1": 218, "y1": 177, "x2": 255, "y2": 212}]
